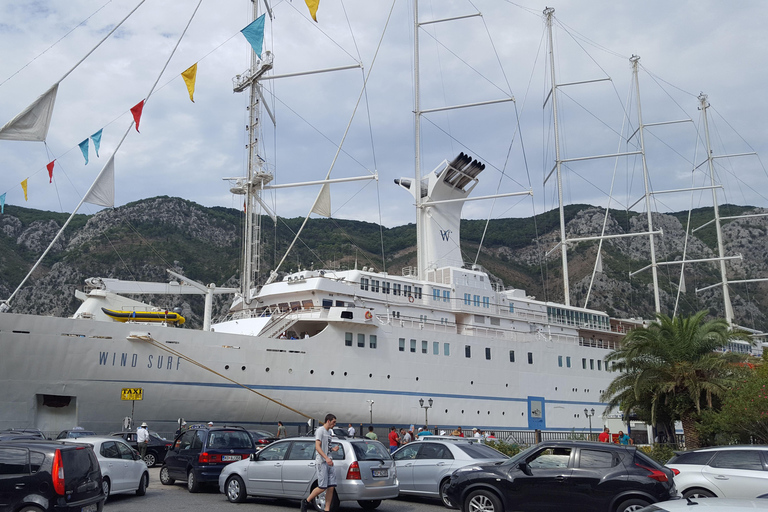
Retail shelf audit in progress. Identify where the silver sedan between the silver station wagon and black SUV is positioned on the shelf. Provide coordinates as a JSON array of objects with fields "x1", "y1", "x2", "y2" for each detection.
[{"x1": 392, "y1": 436, "x2": 509, "y2": 508}]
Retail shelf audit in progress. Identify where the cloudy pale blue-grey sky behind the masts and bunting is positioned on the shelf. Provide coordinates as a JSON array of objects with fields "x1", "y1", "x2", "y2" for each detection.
[{"x1": 0, "y1": 0, "x2": 768, "y2": 227}]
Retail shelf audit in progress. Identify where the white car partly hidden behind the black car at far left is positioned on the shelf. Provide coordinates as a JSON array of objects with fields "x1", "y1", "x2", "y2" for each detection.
[{"x1": 71, "y1": 436, "x2": 149, "y2": 497}]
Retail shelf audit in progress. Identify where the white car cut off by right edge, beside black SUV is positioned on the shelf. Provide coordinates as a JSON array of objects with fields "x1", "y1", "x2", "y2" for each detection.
[{"x1": 667, "y1": 445, "x2": 768, "y2": 498}]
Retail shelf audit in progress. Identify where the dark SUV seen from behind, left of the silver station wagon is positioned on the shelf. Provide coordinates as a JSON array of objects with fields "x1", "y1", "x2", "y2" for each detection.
[{"x1": 160, "y1": 427, "x2": 256, "y2": 492}]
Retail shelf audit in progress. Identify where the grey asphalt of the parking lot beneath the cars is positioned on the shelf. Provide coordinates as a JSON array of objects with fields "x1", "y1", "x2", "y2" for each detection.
[{"x1": 104, "y1": 467, "x2": 448, "y2": 512}]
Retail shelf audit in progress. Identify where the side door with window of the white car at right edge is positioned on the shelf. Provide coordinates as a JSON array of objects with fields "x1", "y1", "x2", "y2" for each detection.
[{"x1": 701, "y1": 449, "x2": 768, "y2": 498}]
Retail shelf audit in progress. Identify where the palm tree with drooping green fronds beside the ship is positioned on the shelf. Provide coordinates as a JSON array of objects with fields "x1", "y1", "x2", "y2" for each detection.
[{"x1": 601, "y1": 311, "x2": 749, "y2": 449}]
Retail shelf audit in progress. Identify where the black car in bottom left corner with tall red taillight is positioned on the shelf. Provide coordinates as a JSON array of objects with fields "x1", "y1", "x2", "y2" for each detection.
[{"x1": 0, "y1": 440, "x2": 106, "y2": 512}]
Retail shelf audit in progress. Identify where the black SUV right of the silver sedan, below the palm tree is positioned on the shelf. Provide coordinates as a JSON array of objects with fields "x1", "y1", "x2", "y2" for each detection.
[{"x1": 446, "y1": 441, "x2": 677, "y2": 512}]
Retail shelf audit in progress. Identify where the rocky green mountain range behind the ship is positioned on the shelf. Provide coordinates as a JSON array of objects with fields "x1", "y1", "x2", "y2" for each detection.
[{"x1": 0, "y1": 197, "x2": 768, "y2": 330}]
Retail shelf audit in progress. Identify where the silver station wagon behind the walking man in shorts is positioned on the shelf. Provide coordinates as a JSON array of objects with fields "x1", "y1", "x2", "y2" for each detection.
[{"x1": 219, "y1": 437, "x2": 398, "y2": 512}]
